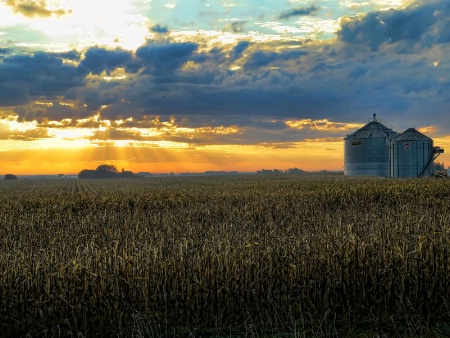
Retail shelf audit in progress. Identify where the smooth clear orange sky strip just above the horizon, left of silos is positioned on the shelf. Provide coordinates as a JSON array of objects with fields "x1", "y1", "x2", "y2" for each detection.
[{"x1": 1, "y1": 142, "x2": 343, "y2": 175}]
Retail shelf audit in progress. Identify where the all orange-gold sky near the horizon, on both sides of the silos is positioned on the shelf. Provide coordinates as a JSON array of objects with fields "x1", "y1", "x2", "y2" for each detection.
[{"x1": 0, "y1": 116, "x2": 450, "y2": 175}]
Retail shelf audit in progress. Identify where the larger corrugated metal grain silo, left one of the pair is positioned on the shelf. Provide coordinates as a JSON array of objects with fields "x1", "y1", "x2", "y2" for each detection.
[{"x1": 344, "y1": 114, "x2": 398, "y2": 177}]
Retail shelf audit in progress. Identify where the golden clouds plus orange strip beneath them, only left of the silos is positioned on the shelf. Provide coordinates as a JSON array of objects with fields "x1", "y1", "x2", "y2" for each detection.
[{"x1": 0, "y1": 114, "x2": 348, "y2": 175}]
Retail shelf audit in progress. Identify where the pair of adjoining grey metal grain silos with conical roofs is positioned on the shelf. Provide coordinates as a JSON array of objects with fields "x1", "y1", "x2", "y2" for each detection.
[{"x1": 344, "y1": 114, "x2": 444, "y2": 177}]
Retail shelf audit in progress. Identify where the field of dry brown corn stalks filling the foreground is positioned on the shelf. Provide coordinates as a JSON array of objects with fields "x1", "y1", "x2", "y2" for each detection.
[{"x1": 0, "y1": 174, "x2": 450, "y2": 337}]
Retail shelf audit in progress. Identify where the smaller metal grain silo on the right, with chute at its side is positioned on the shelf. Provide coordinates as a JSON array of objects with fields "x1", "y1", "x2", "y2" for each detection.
[{"x1": 390, "y1": 128, "x2": 444, "y2": 177}]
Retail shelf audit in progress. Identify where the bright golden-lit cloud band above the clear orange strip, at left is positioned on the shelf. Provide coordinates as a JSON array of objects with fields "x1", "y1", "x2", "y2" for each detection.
[{"x1": 0, "y1": 111, "x2": 244, "y2": 148}]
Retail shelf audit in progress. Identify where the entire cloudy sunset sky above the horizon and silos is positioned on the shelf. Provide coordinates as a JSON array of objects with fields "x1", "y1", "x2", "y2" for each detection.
[{"x1": 0, "y1": 0, "x2": 450, "y2": 175}]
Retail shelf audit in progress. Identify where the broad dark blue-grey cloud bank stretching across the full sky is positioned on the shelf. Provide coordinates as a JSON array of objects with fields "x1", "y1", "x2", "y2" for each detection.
[{"x1": 0, "y1": 2, "x2": 450, "y2": 144}]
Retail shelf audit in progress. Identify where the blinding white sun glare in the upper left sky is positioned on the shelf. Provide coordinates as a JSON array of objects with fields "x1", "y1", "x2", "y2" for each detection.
[{"x1": 0, "y1": 0, "x2": 148, "y2": 50}]
